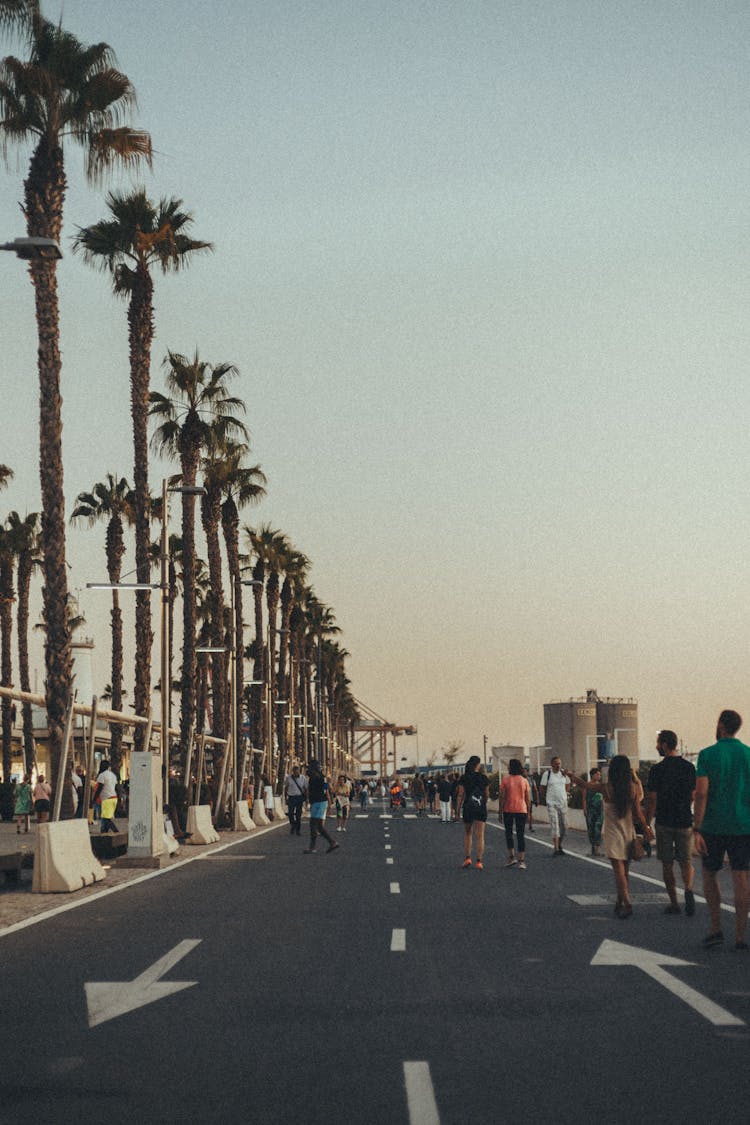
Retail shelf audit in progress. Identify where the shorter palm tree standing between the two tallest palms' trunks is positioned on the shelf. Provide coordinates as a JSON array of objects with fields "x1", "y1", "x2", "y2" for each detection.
[{"x1": 71, "y1": 473, "x2": 135, "y2": 773}]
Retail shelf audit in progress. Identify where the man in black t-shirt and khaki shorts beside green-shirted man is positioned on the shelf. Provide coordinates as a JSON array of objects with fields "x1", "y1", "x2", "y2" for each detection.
[{"x1": 645, "y1": 730, "x2": 695, "y2": 917}]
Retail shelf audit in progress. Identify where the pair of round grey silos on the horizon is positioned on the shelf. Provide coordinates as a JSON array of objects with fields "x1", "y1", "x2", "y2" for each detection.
[{"x1": 544, "y1": 689, "x2": 639, "y2": 774}]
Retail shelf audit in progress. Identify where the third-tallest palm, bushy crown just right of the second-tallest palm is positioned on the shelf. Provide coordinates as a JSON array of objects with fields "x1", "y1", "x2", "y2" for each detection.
[{"x1": 150, "y1": 352, "x2": 247, "y2": 774}]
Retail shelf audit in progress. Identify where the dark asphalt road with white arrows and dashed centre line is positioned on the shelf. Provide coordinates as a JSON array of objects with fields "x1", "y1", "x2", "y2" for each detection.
[{"x1": 0, "y1": 807, "x2": 750, "y2": 1125}]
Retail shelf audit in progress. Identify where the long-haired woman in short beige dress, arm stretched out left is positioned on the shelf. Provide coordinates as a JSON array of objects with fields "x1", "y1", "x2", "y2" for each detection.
[{"x1": 570, "y1": 754, "x2": 652, "y2": 918}]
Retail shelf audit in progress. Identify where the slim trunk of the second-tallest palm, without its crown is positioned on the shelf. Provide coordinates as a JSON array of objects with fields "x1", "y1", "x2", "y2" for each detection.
[{"x1": 129, "y1": 263, "x2": 154, "y2": 750}]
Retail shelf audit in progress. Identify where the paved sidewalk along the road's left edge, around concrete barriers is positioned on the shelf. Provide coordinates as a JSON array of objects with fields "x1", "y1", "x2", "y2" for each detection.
[{"x1": 0, "y1": 817, "x2": 289, "y2": 936}]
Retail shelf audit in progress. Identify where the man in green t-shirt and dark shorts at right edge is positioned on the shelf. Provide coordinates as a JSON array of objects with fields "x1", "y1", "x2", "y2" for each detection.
[{"x1": 693, "y1": 711, "x2": 750, "y2": 950}]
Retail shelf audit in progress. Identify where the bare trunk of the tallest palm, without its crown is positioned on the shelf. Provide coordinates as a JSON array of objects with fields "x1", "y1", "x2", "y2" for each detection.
[{"x1": 24, "y1": 137, "x2": 73, "y2": 817}]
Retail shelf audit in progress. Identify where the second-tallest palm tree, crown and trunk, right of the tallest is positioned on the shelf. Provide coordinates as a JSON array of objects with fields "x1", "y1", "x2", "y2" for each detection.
[{"x1": 73, "y1": 188, "x2": 211, "y2": 745}]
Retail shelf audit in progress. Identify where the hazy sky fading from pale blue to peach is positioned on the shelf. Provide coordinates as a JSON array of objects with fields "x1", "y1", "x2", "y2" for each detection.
[{"x1": 0, "y1": 0, "x2": 750, "y2": 762}]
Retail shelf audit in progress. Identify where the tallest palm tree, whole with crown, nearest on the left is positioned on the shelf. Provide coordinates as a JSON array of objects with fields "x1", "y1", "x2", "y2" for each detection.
[{"x1": 0, "y1": 13, "x2": 151, "y2": 808}]
